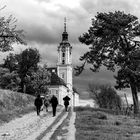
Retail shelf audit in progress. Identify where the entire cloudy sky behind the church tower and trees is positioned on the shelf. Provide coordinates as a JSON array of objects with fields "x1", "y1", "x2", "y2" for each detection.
[{"x1": 0, "y1": 0, "x2": 140, "y2": 95}]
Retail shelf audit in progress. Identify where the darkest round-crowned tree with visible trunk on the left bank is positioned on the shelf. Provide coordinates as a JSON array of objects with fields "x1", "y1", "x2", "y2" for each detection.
[{"x1": 17, "y1": 48, "x2": 40, "y2": 92}]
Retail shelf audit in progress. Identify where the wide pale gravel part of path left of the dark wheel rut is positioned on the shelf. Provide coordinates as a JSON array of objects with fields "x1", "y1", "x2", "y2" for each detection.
[{"x1": 0, "y1": 108, "x2": 62, "y2": 140}]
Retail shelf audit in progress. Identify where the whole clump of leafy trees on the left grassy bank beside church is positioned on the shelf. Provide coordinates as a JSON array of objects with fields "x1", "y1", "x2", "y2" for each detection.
[{"x1": 0, "y1": 48, "x2": 50, "y2": 95}]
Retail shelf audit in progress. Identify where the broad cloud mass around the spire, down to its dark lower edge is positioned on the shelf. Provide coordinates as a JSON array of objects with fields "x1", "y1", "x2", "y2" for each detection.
[{"x1": 2, "y1": 0, "x2": 140, "y2": 44}]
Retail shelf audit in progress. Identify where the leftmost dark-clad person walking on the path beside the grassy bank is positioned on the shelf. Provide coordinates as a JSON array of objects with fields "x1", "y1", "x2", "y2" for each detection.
[{"x1": 34, "y1": 94, "x2": 43, "y2": 115}]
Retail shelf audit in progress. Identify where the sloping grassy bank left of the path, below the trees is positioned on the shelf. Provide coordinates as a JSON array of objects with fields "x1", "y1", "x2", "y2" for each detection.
[{"x1": 0, "y1": 89, "x2": 34, "y2": 124}]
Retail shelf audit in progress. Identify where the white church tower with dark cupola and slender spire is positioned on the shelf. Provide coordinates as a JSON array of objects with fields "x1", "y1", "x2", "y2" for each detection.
[{"x1": 57, "y1": 18, "x2": 73, "y2": 92}]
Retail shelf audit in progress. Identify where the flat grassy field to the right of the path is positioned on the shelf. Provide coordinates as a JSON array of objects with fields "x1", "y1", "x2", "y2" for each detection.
[{"x1": 75, "y1": 107, "x2": 140, "y2": 140}]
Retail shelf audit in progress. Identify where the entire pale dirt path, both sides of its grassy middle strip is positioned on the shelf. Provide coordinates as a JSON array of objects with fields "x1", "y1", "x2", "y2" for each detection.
[{"x1": 0, "y1": 107, "x2": 75, "y2": 140}]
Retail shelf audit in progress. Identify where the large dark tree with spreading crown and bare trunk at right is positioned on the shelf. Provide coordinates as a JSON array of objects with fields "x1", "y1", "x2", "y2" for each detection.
[{"x1": 75, "y1": 11, "x2": 140, "y2": 114}]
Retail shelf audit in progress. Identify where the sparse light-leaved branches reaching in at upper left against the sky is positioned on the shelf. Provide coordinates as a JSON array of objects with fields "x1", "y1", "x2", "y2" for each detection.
[{"x1": 0, "y1": 15, "x2": 26, "y2": 52}]
